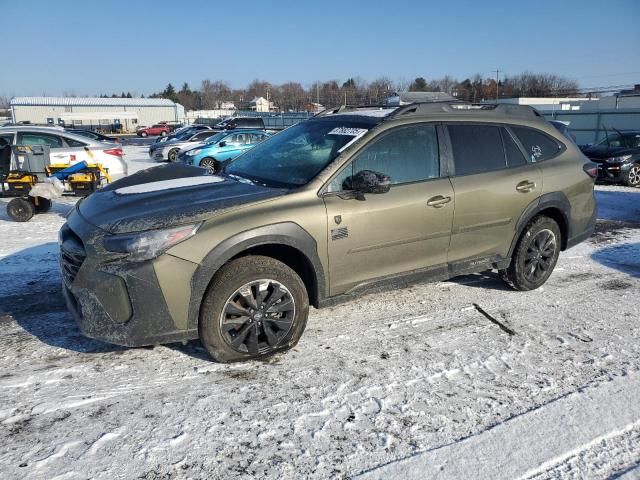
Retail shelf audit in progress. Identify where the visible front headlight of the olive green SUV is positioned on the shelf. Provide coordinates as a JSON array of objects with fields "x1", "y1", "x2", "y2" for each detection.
[{"x1": 102, "y1": 223, "x2": 202, "y2": 262}]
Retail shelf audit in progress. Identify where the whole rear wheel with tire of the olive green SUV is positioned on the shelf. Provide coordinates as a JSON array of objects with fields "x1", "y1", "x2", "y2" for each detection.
[{"x1": 499, "y1": 216, "x2": 562, "y2": 291}]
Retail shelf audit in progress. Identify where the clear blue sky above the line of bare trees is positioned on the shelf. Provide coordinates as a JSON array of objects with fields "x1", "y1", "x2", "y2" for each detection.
[{"x1": 0, "y1": 0, "x2": 640, "y2": 96}]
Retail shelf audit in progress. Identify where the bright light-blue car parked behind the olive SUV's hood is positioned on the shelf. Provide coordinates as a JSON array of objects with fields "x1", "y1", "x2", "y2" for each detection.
[{"x1": 178, "y1": 129, "x2": 271, "y2": 173}]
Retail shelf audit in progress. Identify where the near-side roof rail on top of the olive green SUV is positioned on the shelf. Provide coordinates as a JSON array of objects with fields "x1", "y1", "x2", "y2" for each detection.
[{"x1": 387, "y1": 101, "x2": 542, "y2": 120}]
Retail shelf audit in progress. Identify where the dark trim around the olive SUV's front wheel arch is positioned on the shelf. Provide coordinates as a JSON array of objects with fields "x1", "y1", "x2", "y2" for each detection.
[{"x1": 188, "y1": 222, "x2": 326, "y2": 329}]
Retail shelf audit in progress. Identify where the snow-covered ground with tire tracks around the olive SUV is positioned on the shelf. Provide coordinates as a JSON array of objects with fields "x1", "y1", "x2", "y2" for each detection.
[{"x1": 0, "y1": 147, "x2": 640, "y2": 479}]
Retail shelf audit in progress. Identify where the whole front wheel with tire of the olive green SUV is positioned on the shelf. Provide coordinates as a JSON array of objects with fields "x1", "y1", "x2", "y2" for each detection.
[{"x1": 198, "y1": 255, "x2": 309, "y2": 363}]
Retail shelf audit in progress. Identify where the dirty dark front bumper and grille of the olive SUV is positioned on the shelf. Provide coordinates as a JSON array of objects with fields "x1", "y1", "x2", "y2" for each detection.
[{"x1": 60, "y1": 219, "x2": 198, "y2": 347}]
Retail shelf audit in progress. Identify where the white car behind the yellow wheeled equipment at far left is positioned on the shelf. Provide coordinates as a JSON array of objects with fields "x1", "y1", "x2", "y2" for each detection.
[{"x1": 0, "y1": 125, "x2": 128, "y2": 179}]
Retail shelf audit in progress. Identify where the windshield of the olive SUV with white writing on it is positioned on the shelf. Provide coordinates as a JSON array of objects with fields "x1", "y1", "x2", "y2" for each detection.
[{"x1": 225, "y1": 117, "x2": 375, "y2": 187}]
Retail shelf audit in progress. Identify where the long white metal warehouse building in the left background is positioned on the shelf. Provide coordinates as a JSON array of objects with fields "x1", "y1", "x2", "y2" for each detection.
[{"x1": 11, "y1": 97, "x2": 184, "y2": 132}]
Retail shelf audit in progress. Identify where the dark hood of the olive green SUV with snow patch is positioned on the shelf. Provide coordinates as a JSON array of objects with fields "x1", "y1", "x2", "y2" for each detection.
[{"x1": 76, "y1": 164, "x2": 287, "y2": 233}]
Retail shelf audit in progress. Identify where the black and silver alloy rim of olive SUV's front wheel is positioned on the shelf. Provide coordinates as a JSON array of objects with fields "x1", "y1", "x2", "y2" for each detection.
[{"x1": 220, "y1": 279, "x2": 296, "y2": 355}]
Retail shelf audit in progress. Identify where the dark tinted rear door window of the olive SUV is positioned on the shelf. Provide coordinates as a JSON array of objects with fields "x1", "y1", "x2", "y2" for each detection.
[{"x1": 447, "y1": 124, "x2": 507, "y2": 176}]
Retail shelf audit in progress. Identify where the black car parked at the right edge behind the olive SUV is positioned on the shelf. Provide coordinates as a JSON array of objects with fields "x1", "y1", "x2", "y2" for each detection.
[{"x1": 580, "y1": 131, "x2": 640, "y2": 187}]
